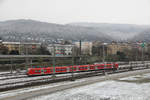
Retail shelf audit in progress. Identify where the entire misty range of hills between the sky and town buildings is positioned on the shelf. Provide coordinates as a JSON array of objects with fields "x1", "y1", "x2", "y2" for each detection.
[{"x1": 0, "y1": 19, "x2": 150, "y2": 43}]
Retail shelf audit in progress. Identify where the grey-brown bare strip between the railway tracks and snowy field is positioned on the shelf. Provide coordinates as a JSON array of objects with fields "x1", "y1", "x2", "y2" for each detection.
[{"x1": 0, "y1": 69, "x2": 150, "y2": 100}]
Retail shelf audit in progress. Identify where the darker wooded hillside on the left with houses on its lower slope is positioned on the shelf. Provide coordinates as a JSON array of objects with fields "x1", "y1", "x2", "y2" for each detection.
[{"x1": 0, "y1": 20, "x2": 112, "y2": 42}]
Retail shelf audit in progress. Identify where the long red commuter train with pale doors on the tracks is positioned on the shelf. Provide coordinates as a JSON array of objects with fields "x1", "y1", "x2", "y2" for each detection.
[{"x1": 27, "y1": 63, "x2": 118, "y2": 76}]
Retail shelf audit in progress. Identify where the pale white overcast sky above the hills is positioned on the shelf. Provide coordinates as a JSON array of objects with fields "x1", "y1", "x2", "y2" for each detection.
[{"x1": 0, "y1": 0, "x2": 150, "y2": 25}]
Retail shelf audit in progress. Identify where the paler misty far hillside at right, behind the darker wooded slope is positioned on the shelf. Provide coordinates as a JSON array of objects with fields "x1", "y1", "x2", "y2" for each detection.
[{"x1": 68, "y1": 23, "x2": 150, "y2": 40}]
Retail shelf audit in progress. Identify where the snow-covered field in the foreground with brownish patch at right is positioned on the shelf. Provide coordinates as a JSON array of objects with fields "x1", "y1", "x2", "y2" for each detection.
[{"x1": 28, "y1": 74, "x2": 150, "y2": 100}]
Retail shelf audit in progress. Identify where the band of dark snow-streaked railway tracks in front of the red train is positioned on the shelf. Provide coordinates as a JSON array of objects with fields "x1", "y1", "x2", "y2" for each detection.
[{"x1": 0, "y1": 64, "x2": 149, "y2": 91}]
